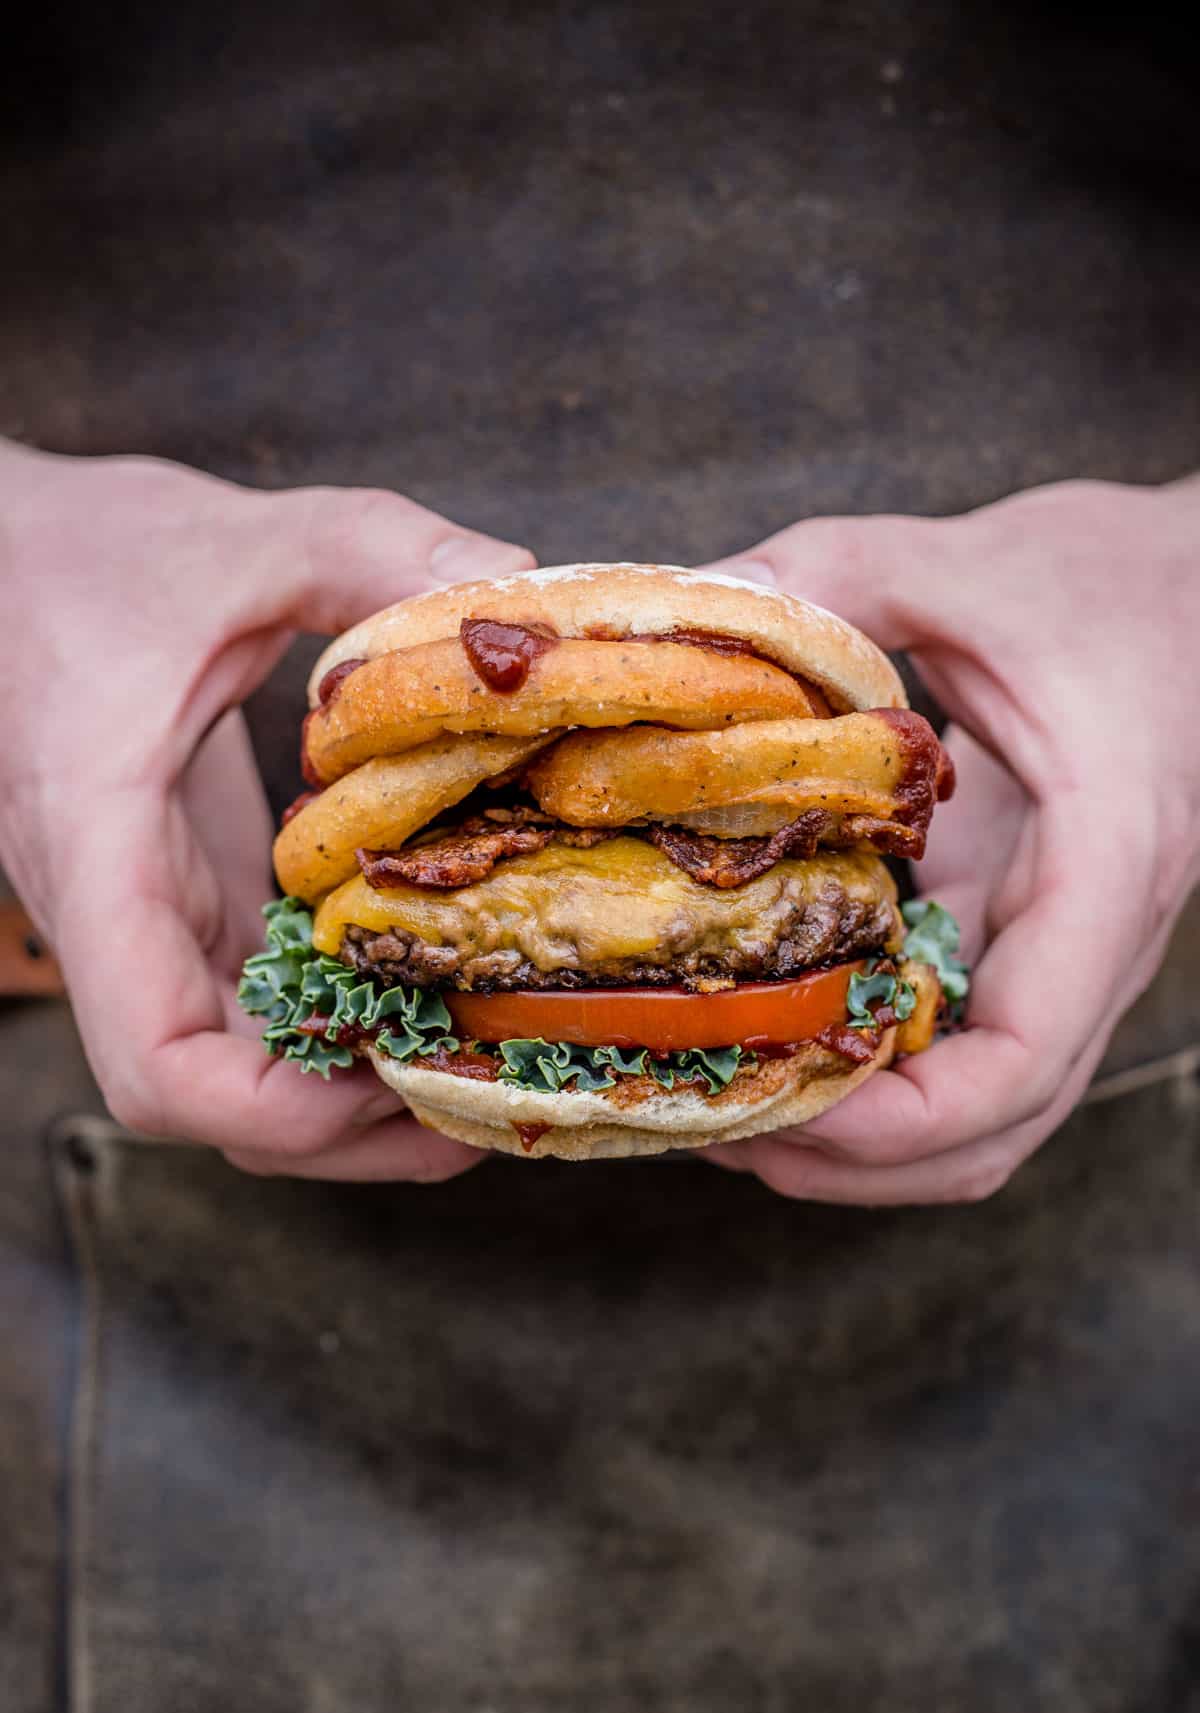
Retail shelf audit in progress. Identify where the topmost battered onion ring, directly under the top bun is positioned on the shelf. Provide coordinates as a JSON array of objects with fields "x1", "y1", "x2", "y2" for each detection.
[{"x1": 305, "y1": 637, "x2": 815, "y2": 785}]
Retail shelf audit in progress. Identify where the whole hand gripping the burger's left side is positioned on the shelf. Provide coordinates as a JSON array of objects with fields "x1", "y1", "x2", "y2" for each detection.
[{"x1": 0, "y1": 442, "x2": 532, "y2": 1179}]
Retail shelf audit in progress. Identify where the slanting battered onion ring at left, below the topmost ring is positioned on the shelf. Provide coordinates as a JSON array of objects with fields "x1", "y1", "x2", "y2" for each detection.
[{"x1": 274, "y1": 731, "x2": 558, "y2": 904}]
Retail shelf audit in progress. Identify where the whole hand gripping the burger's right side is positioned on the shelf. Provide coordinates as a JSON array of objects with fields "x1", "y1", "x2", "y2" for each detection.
[{"x1": 701, "y1": 478, "x2": 1200, "y2": 1204}]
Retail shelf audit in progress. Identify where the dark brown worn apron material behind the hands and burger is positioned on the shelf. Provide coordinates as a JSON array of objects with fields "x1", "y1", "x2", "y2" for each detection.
[{"x1": 0, "y1": 0, "x2": 1200, "y2": 1713}]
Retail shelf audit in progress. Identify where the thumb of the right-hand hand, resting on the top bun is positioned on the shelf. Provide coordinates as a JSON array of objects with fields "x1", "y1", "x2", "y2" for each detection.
[{"x1": 707, "y1": 516, "x2": 953, "y2": 653}]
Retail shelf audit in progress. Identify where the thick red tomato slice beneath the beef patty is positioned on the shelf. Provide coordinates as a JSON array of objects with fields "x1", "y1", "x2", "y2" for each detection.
[{"x1": 443, "y1": 961, "x2": 863, "y2": 1052}]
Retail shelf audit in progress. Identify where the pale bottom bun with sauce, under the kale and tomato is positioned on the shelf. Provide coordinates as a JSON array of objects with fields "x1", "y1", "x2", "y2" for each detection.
[{"x1": 368, "y1": 1030, "x2": 895, "y2": 1160}]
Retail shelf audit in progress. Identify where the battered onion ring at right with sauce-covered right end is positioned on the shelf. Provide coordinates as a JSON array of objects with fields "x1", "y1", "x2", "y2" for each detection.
[{"x1": 526, "y1": 707, "x2": 953, "y2": 833}]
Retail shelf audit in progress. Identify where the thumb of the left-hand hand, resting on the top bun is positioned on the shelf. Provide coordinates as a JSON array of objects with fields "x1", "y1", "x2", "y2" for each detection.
[{"x1": 264, "y1": 488, "x2": 536, "y2": 634}]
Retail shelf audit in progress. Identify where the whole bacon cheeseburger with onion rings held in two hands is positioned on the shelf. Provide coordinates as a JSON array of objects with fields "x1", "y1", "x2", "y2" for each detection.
[{"x1": 238, "y1": 565, "x2": 965, "y2": 1160}]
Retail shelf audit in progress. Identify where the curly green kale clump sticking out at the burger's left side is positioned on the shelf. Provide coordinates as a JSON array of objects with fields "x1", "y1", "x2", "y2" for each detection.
[{"x1": 238, "y1": 898, "x2": 459, "y2": 1079}]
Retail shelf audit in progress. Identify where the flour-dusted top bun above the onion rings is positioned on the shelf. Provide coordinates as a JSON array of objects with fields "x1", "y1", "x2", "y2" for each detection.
[{"x1": 308, "y1": 564, "x2": 907, "y2": 713}]
